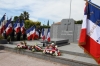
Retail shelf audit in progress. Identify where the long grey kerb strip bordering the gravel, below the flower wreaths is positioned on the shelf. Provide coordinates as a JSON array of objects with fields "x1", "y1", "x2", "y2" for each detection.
[{"x1": 4, "y1": 47, "x2": 97, "y2": 66}]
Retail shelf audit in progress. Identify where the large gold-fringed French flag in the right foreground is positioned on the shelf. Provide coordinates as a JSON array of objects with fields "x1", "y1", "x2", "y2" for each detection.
[{"x1": 79, "y1": 1, "x2": 100, "y2": 64}]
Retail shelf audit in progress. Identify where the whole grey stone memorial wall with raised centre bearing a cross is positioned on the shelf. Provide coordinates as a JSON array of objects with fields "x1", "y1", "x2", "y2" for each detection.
[{"x1": 51, "y1": 19, "x2": 81, "y2": 42}]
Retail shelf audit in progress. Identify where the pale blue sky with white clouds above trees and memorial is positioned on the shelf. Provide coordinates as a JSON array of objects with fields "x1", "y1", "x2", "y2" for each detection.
[{"x1": 0, "y1": 0, "x2": 100, "y2": 25}]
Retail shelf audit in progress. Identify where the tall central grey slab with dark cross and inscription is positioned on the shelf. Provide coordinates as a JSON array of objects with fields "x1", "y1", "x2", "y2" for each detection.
[{"x1": 61, "y1": 19, "x2": 75, "y2": 42}]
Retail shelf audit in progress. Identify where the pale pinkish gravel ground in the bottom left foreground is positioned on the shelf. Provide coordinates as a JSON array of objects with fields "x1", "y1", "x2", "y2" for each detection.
[{"x1": 0, "y1": 50, "x2": 68, "y2": 66}]
